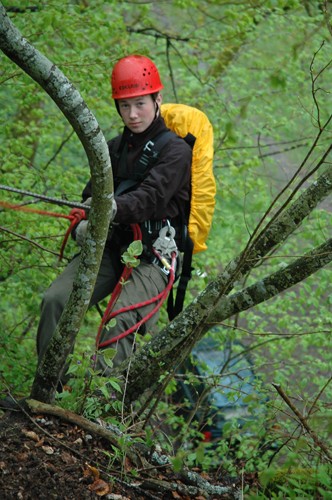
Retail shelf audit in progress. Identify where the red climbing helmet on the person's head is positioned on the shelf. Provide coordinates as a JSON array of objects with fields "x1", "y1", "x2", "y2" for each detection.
[{"x1": 111, "y1": 55, "x2": 164, "y2": 99}]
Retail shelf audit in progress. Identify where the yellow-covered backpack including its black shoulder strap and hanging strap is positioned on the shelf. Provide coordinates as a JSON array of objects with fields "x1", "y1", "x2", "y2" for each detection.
[{"x1": 115, "y1": 104, "x2": 216, "y2": 319}]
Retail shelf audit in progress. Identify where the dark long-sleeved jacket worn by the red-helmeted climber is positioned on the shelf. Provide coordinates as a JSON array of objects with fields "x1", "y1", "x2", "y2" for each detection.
[{"x1": 83, "y1": 117, "x2": 192, "y2": 246}]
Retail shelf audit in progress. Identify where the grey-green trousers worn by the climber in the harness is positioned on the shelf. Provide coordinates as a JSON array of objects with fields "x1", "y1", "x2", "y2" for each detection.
[{"x1": 37, "y1": 249, "x2": 168, "y2": 376}]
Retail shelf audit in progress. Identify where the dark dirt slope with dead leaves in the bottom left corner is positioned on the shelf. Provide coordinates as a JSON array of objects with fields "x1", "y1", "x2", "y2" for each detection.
[{"x1": 0, "y1": 412, "x2": 255, "y2": 500}]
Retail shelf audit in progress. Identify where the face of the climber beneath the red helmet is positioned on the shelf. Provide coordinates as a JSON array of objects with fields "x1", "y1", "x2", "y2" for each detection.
[{"x1": 118, "y1": 94, "x2": 161, "y2": 134}]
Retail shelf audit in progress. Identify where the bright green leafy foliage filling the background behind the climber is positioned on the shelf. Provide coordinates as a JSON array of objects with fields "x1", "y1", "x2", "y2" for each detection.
[{"x1": 0, "y1": 0, "x2": 332, "y2": 492}]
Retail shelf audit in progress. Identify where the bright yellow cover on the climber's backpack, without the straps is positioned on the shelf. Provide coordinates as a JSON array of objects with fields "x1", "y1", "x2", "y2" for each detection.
[{"x1": 161, "y1": 104, "x2": 216, "y2": 253}]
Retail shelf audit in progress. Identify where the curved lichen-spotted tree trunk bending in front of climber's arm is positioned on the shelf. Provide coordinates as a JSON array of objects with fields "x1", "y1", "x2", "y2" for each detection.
[{"x1": 0, "y1": 4, "x2": 113, "y2": 403}]
